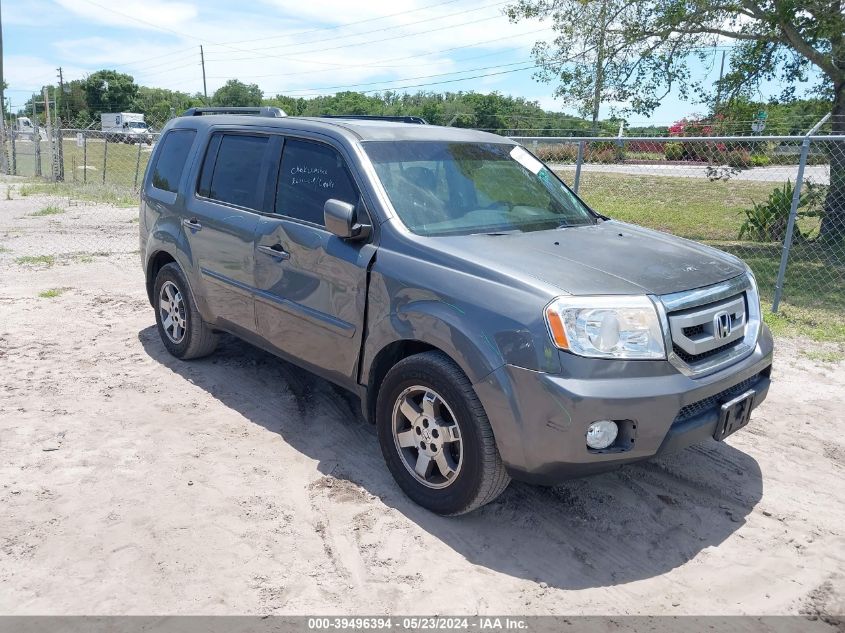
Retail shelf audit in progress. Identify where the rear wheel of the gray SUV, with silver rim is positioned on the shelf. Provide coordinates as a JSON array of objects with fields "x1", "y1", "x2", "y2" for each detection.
[{"x1": 153, "y1": 263, "x2": 217, "y2": 360}]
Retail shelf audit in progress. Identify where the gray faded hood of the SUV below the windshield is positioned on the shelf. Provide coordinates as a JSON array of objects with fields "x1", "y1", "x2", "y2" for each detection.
[{"x1": 428, "y1": 221, "x2": 745, "y2": 295}]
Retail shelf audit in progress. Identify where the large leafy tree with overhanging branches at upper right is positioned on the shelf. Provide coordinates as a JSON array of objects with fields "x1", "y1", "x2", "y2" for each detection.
[{"x1": 507, "y1": 0, "x2": 845, "y2": 237}]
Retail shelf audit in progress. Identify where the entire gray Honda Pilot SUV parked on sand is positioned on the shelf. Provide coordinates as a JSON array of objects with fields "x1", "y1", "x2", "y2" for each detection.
[{"x1": 140, "y1": 109, "x2": 772, "y2": 515}]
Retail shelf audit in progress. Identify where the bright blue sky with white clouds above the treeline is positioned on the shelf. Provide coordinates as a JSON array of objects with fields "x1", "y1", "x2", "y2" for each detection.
[{"x1": 2, "y1": 0, "x2": 816, "y2": 123}]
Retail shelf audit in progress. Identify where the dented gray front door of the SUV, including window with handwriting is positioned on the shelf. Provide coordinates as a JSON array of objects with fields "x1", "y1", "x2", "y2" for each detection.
[{"x1": 255, "y1": 138, "x2": 375, "y2": 383}]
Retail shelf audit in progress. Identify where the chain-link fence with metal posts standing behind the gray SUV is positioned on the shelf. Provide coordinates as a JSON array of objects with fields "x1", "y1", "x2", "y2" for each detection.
[{"x1": 6, "y1": 116, "x2": 845, "y2": 330}]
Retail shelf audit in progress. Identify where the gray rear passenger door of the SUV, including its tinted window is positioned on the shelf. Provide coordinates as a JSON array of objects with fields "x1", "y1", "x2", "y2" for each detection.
[{"x1": 183, "y1": 130, "x2": 271, "y2": 332}]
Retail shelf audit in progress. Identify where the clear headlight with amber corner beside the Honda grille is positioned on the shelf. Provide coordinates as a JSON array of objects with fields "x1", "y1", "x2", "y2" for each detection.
[{"x1": 546, "y1": 296, "x2": 666, "y2": 359}]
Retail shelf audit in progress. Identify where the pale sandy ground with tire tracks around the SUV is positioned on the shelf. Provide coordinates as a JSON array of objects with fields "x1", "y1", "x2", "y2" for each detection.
[{"x1": 0, "y1": 180, "x2": 845, "y2": 614}]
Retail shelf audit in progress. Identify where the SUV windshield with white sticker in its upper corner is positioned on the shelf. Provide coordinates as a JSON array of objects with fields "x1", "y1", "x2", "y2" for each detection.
[{"x1": 364, "y1": 141, "x2": 596, "y2": 235}]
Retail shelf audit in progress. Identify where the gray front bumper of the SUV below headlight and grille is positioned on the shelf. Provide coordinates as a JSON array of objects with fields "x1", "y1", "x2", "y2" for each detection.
[{"x1": 475, "y1": 326, "x2": 773, "y2": 484}]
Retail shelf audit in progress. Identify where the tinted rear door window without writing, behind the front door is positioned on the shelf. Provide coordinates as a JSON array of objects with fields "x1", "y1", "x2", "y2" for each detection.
[{"x1": 199, "y1": 134, "x2": 269, "y2": 209}]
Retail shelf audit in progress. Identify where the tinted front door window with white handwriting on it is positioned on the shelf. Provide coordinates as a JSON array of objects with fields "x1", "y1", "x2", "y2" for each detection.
[{"x1": 276, "y1": 139, "x2": 358, "y2": 226}]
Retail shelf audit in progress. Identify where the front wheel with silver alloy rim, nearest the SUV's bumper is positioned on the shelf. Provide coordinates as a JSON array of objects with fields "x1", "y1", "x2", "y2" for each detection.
[{"x1": 376, "y1": 351, "x2": 510, "y2": 516}]
